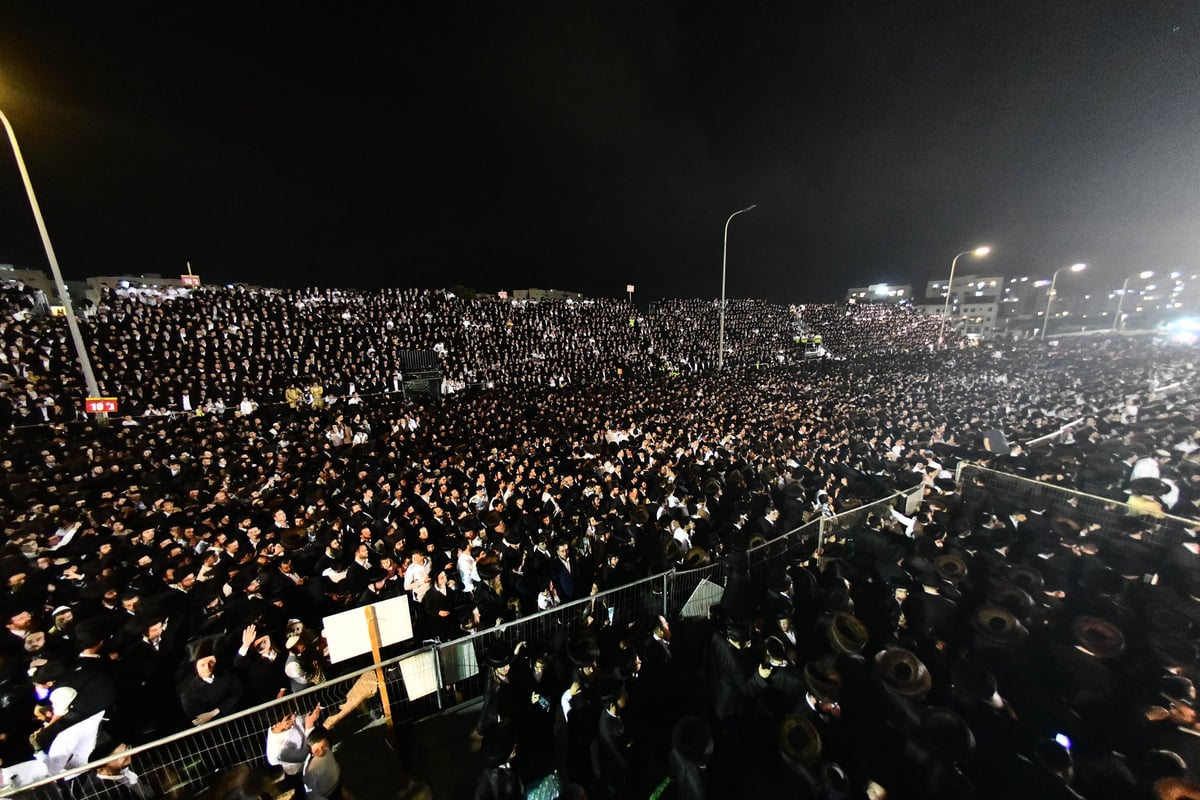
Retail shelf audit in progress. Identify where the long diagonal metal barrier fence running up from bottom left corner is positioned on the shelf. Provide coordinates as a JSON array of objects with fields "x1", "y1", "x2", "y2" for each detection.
[{"x1": 0, "y1": 487, "x2": 919, "y2": 800}]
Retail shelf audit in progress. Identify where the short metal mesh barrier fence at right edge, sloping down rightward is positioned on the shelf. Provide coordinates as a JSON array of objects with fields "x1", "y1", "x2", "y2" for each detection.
[{"x1": 956, "y1": 463, "x2": 1200, "y2": 556}]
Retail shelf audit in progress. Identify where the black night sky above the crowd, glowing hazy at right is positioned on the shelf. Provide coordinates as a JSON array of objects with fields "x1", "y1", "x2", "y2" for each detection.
[{"x1": 0, "y1": 0, "x2": 1200, "y2": 301}]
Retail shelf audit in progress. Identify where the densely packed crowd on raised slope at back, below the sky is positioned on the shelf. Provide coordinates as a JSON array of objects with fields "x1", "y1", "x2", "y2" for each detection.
[{"x1": 0, "y1": 285, "x2": 955, "y2": 427}]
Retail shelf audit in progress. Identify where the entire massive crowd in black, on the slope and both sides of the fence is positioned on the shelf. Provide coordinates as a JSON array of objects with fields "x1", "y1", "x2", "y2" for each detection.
[{"x1": 0, "y1": 278, "x2": 1200, "y2": 796}]
